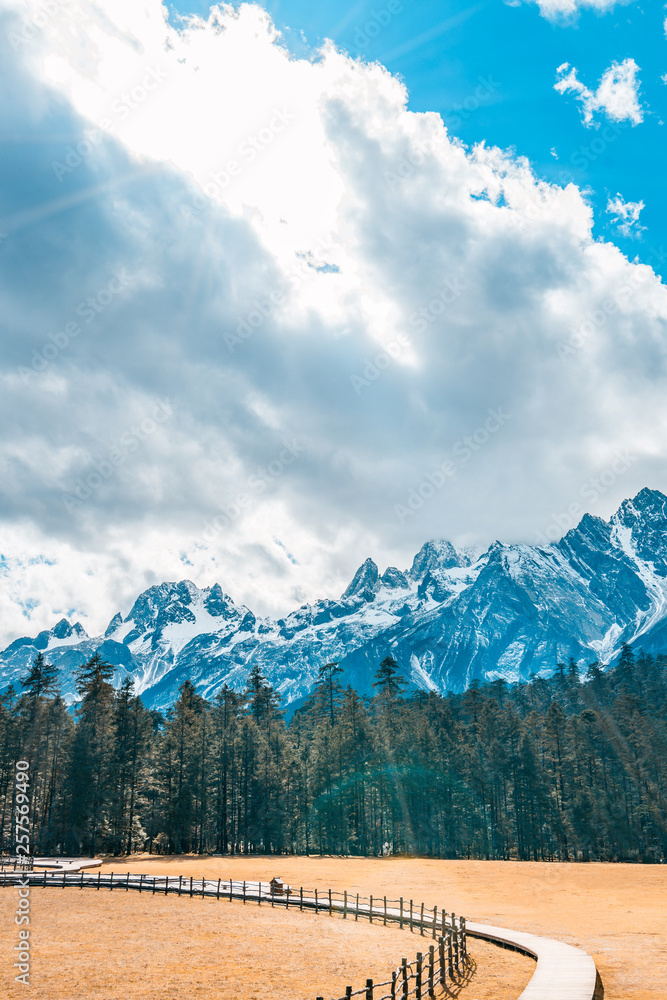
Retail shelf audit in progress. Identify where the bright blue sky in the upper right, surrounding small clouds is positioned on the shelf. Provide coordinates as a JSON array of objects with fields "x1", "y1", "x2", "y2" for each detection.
[{"x1": 168, "y1": 0, "x2": 667, "y2": 274}]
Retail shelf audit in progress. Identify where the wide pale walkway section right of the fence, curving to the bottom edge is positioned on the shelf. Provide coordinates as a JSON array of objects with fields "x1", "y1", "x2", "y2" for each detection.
[{"x1": 466, "y1": 923, "x2": 597, "y2": 1000}]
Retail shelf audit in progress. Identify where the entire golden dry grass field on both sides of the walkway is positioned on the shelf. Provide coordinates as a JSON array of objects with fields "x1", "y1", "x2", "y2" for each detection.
[{"x1": 0, "y1": 855, "x2": 667, "y2": 1000}]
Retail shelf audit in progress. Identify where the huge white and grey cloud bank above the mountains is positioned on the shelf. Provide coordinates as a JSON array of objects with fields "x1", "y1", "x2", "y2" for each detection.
[{"x1": 0, "y1": 0, "x2": 667, "y2": 635}]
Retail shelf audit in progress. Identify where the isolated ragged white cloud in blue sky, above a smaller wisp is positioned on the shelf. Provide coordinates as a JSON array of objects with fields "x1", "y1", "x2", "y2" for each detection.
[{"x1": 554, "y1": 59, "x2": 644, "y2": 125}]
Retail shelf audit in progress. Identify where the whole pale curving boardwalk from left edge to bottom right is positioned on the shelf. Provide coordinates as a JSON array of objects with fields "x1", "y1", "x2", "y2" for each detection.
[{"x1": 0, "y1": 858, "x2": 603, "y2": 1000}]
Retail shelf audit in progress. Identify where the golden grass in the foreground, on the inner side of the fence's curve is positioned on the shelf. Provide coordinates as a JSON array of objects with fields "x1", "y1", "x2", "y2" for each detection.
[{"x1": 0, "y1": 884, "x2": 535, "y2": 1000}]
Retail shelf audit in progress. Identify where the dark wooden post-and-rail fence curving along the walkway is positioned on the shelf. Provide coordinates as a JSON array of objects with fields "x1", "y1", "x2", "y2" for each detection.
[{"x1": 0, "y1": 870, "x2": 468, "y2": 1000}]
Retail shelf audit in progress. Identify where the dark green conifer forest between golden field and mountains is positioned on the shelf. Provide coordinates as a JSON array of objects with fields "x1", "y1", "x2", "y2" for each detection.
[{"x1": 0, "y1": 646, "x2": 667, "y2": 862}]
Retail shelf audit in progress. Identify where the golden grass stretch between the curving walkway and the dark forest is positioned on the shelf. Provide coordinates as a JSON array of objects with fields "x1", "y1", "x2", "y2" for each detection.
[{"x1": 105, "y1": 855, "x2": 667, "y2": 1000}]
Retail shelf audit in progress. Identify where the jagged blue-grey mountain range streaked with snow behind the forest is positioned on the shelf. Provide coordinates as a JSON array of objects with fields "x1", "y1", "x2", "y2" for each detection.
[{"x1": 0, "y1": 489, "x2": 667, "y2": 708}]
